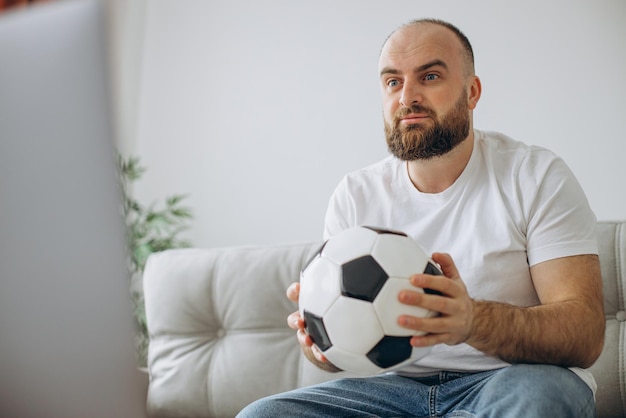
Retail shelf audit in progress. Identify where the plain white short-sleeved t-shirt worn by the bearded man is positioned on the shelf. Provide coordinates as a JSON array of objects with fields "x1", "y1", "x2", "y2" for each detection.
[{"x1": 324, "y1": 130, "x2": 598, "y2": 393}]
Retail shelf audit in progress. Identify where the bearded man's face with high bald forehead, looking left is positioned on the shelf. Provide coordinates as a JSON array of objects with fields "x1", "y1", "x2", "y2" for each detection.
[{"x1": 379, "y1": 24, "x2": 477, "y2": 161}]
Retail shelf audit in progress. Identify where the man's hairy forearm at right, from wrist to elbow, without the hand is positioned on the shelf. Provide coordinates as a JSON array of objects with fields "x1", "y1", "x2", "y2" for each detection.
[{"x1": 466, "y1": 301, "x2": 604, "y2": 368}]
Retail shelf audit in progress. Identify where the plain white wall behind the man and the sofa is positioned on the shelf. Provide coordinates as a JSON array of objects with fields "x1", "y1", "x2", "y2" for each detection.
[{"x1": 135, "y1": 0, "x2": 626, "y2": 247}]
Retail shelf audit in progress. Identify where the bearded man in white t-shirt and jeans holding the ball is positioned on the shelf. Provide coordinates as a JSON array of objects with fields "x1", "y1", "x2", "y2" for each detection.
[{"x1": 236, "y1": 20, "x2": 604, "y2": 418}]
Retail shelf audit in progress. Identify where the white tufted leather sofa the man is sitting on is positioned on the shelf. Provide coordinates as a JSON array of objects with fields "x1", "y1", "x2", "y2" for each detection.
[{"x1": 144, "y1": 222, "x2": 626, "y2": 418}]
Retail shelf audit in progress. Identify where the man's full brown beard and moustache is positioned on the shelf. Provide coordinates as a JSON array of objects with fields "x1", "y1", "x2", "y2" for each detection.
[{"x1": 385, "y1": 91, "x2": 470, "y2": 161}]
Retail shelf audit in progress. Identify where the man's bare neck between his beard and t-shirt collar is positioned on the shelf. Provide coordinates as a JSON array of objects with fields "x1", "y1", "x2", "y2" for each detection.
[{"x1": 407, "y1": 130, "x2": 474, "y2": 193}]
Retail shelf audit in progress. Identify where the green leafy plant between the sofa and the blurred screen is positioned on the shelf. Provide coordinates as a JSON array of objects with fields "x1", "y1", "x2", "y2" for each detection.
[{"x1": 118, "y1": 154, "x2": 193, "y2": 367}]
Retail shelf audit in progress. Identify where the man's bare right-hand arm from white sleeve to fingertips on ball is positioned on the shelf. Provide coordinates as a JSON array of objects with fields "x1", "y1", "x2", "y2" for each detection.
[{"x1": 399, "y1": 254, "x2": 605, "y2": 368}]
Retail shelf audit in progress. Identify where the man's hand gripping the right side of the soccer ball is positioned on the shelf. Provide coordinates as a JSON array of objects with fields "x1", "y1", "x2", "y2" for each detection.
[{"x1": 398, "y1": 253, "x2": 474, "y2": 347}]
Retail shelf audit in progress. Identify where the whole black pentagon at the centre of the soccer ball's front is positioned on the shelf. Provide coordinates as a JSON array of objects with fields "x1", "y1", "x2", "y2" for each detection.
[{"x1": 341, "y1": 255, "x2": 389, "y2": 302}]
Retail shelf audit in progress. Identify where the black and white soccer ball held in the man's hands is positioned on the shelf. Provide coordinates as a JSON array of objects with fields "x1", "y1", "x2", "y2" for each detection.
[{"x1": 298, "y1": 226, "x2": 442, "y2": 375}]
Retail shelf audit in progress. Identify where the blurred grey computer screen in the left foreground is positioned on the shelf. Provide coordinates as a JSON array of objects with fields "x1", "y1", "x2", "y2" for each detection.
[{"x1": 0, "y1": 0, "x2": 145, "y2": 418}]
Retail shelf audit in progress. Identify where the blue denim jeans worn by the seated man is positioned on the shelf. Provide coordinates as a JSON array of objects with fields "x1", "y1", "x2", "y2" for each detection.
[{"x1": 238, "y1": 364, "x2": 596, "y2": 418}]
